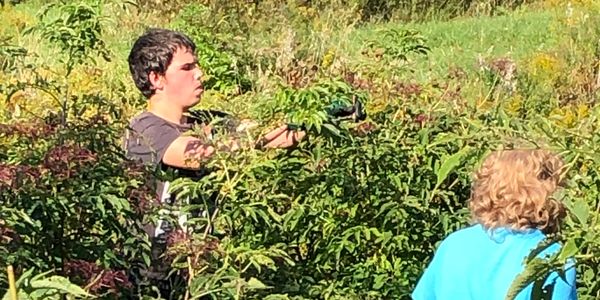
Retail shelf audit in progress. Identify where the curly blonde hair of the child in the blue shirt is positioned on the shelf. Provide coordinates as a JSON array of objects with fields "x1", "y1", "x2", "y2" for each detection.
[{"x1": 469, "y1": 150, "x2": 565, "y2": 233}]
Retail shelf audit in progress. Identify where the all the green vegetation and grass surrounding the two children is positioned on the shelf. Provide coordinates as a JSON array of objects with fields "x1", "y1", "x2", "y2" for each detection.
[{"x1": 0, "y1": 0, "x2": 600, "y2": 299}]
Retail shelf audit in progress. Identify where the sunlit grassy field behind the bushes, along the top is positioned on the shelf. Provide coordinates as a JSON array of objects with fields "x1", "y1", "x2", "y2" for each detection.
[{"x1": 0, "y1": 1, "x2": 594, "y2": 117}]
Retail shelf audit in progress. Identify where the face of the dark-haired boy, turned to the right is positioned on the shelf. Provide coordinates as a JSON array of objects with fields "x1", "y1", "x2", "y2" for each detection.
[{"x1": 163, "y1": 48, "x2": 204, "y2": 109}]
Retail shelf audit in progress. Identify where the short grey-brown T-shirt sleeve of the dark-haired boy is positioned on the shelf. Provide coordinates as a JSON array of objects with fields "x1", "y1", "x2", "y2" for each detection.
[{"x1": 124, "y1": 114, "x2": 181, "y2": 166}]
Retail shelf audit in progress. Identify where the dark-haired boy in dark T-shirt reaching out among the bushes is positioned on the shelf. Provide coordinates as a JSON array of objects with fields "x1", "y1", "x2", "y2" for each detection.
[{"x1": 124, "y1": 29, "x2": 305, "y2": 296}]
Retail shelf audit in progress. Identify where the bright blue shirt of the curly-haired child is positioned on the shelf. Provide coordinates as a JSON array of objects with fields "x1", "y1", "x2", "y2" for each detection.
[{"x1": 412, "y1": 224, "x2": 577, "y2": 300}]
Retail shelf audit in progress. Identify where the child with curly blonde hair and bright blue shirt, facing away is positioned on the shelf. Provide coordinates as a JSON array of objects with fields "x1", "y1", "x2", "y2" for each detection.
[{"x1": 412, "y1": 150, "x2": 577, "y2": 300}]
